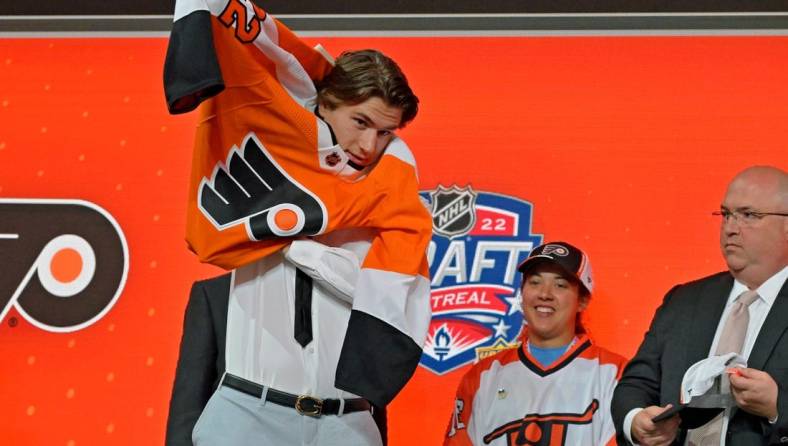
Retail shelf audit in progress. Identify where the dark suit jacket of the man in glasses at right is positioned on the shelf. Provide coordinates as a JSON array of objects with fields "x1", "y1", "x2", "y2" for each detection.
[{"x1": 611, "y1": 272, "x2": 788, "y2": 446}]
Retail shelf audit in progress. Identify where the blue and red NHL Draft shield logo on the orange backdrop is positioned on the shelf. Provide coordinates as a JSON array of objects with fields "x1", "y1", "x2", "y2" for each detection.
[{"x1": 420, "y1": 185, "x2": 542, "y2": 375}]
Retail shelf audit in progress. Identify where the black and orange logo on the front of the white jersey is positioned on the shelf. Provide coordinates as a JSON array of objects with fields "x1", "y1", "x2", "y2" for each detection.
[{"x1": 484, "y1": 400, "x2": 599, "y2": 446}]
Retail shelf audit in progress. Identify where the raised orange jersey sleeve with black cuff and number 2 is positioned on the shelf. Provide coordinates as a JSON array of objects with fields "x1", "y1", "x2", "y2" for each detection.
[{"x1": 164, "y1": 0, "x2": 331, "y2": 114}]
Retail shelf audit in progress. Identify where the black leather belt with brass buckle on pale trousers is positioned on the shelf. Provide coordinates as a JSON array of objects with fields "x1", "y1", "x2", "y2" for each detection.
[{"x1": 222, "y1": 373, "x2": 372, "y2": 417}]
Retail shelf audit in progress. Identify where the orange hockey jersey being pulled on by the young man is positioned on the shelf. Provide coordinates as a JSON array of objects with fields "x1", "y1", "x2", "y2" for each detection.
[{"x1": 164, "y1": 0, "x2": 432, "y2": 405}]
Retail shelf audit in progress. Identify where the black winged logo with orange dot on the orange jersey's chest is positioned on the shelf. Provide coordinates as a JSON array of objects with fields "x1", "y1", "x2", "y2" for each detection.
[{"x1": 203, "y1": 133, "x2": 327, "y2": 240}]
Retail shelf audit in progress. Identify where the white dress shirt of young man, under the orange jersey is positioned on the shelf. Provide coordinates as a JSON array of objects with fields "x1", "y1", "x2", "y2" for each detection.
[{"x1": 226, "y1": 229, "x2": 372, "y2": 398}]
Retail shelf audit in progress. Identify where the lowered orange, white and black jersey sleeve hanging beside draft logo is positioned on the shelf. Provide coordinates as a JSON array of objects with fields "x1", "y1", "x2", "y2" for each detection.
[{"x1": 336, "y1": 151, "x2": 432, "y2": 406}]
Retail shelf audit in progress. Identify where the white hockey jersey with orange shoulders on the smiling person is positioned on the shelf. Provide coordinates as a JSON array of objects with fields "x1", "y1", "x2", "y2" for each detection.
[{"x1": 444, "y1": 330, "x2": 626, "y2": 446}]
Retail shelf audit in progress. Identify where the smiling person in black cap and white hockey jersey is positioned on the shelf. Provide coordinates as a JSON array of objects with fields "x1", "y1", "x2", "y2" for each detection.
[{"x1": 444, "y1": 242, "x2": 626, "y2": 445}]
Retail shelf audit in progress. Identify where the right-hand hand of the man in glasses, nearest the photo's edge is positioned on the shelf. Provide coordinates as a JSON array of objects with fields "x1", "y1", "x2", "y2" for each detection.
[{"x1": 729, "y1": 367, "x2": 777, "y2": 420}]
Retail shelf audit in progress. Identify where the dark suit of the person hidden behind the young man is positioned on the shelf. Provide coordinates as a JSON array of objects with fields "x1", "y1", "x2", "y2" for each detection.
[{"x1": 165, "y1": 274, "x2": 387, "y2": 446}]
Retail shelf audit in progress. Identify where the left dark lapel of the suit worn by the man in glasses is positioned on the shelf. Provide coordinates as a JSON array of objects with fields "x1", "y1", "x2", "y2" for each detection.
[{"x1": 687, "y1": 274, "x2": 733, "y2": 368}]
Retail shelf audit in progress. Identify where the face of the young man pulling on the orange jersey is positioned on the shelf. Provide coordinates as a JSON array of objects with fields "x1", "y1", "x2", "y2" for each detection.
[{"x1": 319, "y1": 97, "x2": 402, "y2": 167}]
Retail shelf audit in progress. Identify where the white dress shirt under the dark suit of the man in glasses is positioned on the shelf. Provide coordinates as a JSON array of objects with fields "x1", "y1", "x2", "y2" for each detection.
[{"x1": 623, "y1": 266, "x2": 788, "y2": 446}]
